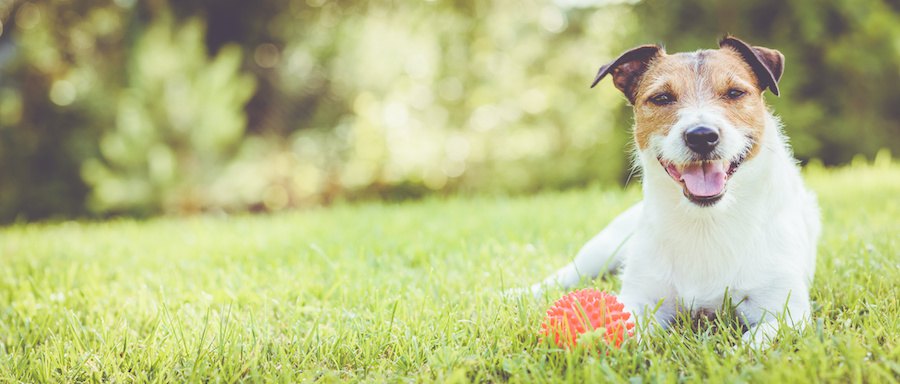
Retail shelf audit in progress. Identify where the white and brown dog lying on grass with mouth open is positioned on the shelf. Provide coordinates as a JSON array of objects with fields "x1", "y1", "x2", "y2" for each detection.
[{"x1": 530, "y1": 36, "x2": 821, "y2": 346}]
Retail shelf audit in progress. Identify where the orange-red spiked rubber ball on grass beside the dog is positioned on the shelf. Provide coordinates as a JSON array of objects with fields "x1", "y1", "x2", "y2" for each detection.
[{"x1": 541, "y1": 289, "x2": 634, "y2": 348}]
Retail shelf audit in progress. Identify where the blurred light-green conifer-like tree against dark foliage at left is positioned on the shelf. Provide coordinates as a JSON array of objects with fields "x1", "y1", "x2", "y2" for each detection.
[{"x1": 82, "y1": 16, "x2": 254, "y2": 213}]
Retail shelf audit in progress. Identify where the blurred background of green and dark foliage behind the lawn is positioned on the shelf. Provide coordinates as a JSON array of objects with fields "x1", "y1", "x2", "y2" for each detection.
[{"x1": 0, "y1": 0, "x2": 900, "y2": 223}]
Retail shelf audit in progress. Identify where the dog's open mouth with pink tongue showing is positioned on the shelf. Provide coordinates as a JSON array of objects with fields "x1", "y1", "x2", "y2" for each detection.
[{"x1": 659, "y1": 157, "x2": 744, "y2": 207}]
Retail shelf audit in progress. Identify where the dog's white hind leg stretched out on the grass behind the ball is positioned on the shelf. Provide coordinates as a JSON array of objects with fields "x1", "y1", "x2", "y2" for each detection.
[{"x1": 531, "y1": 203, "x2": 643, "y2": 297}]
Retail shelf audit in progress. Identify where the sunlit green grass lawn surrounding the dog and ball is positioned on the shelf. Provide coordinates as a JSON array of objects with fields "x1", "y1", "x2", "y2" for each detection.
[{"x1": 0, "y1": 159, "x2": 900, "y2": 382}]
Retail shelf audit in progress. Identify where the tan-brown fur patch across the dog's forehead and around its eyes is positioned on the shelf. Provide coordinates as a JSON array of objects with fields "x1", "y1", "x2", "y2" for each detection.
[{"x1": 634, "y1": 47, "x2": 766, "y2": 158}]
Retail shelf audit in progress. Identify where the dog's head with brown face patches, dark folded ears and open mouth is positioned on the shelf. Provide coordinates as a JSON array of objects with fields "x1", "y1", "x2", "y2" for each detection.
[{"x1": 592, "y1": 36, "x2": 784, "y2": 206}]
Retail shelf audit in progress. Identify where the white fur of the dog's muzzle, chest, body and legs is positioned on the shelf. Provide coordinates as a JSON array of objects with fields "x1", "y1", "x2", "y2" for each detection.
[{"x1": 531, "y1": 112, "x2": 820, "y2": 346}]
